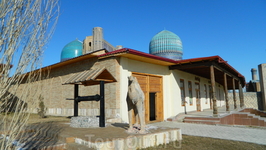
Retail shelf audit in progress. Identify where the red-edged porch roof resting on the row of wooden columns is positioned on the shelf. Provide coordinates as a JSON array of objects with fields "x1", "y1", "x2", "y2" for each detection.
[{"x1": 169, "y1": 56, "x2": 245, "y2": 90}]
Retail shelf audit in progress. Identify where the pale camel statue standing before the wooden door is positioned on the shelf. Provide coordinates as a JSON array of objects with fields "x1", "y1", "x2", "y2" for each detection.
[{"x1": 127, "y1": 76, "x2": 146, "y2": 134}]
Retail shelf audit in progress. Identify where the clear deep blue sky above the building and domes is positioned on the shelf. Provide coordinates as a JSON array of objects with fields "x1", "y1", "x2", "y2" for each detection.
[{"x1": 43, "y1": 0, "x2": 266, "y2": 82}]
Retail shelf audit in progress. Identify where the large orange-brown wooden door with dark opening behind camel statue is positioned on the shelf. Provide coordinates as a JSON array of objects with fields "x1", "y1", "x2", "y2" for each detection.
[{"x1": 132, "y1": 73, "x2": 163, "y2": 123}]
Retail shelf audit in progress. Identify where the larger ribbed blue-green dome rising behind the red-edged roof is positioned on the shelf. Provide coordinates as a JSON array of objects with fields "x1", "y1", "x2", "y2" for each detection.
[{"x1": 149, "y1": 30, "x2": 183, "y2": 60}]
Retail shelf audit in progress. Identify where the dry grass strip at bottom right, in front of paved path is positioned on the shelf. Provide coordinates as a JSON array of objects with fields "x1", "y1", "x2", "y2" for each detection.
[{"x1": 141, "y1": 135, "x2": 266, "y2": 150}]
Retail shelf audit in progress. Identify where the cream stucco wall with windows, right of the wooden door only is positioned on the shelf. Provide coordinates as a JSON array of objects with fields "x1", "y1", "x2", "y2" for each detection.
[{"x1": 163, "y1": 70, "x2": 224, "y2": 119}]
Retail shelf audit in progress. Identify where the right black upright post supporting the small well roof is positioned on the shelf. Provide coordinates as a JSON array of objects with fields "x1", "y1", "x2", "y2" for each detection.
[{"x1": 99, "y1": 81, "x2": 105, "y2": 127}]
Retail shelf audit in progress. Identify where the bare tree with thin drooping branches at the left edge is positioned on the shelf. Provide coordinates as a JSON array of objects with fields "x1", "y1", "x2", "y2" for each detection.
[{"x1": 0, "y1": 0, "x2": 59, "y2": 149}]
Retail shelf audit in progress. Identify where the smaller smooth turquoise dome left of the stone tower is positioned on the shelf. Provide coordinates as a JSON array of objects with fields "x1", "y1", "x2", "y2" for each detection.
[{"x1": 61, "y1": 40, "x2": 83, "y2": 61}]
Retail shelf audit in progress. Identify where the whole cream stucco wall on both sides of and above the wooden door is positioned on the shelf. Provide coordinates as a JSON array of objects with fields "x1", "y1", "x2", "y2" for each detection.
[{"x1": 120, "y1": 57, "x2": 224, "y2": 122}]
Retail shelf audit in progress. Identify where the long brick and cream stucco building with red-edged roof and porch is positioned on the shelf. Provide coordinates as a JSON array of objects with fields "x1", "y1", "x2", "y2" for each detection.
[{"x1": 11, "y1": 27, "x2": 245, "y2": 123}]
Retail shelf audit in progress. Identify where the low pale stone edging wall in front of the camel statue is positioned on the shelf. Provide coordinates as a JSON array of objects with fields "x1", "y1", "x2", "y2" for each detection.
[{"x1": 75, "y1": 129, "x2": 182, "y2": 150}]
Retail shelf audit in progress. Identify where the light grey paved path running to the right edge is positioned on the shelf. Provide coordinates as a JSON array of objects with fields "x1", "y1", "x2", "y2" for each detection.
[{"x1": 149, "y1": 122, "x2": 266, "y2": 145}]
